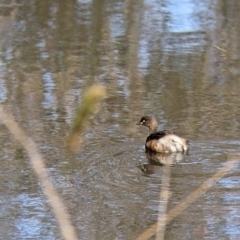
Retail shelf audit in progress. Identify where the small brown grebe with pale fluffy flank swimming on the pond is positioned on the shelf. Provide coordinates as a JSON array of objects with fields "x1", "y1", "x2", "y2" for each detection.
[{"x1": 137, "y1": 116, "x2": 189, "y2": 153}]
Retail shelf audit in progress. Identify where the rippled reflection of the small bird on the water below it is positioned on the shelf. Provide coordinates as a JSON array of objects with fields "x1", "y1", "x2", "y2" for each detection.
[{"x1": 139, "y1": 151, "x2": 184, "y2": 174}]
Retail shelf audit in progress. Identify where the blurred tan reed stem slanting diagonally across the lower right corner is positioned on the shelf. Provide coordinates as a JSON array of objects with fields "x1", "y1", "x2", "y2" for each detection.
[{"x1": 136, "y1": 154, "x2": 240, "y2": 240}]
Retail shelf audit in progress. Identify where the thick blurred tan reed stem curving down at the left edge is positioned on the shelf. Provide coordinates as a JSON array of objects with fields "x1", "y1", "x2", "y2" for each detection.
[{"x1": 0, "y1": 105, "x2": 77, "y2": 240}]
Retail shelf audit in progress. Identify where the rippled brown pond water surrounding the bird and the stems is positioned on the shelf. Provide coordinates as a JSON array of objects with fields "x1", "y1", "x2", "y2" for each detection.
[{"x1": 0, "y1": 0, "x2": 240, "y2": 240}]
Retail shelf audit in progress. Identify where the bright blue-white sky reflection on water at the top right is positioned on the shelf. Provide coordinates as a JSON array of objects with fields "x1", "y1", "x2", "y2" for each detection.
[{"x1": 139, "y1": 0, "x2": 202, "y2": 69}]
